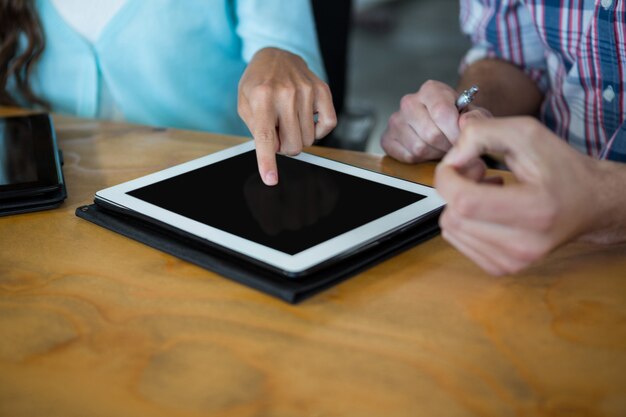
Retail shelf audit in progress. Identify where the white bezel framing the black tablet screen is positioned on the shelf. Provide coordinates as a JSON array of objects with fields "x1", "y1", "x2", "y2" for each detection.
[{"x1": 96, "y1": 141, "x2": 445, "y2": 275}]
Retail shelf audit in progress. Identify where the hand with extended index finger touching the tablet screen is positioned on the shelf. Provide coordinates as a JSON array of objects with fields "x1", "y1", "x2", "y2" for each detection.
[{"x1": 238, "y1": 48, "x2": 337, "y2": 185}]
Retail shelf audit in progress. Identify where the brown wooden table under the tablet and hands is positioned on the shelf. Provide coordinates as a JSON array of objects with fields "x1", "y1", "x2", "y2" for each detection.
[{"x1": 0, "y1": 109, "x2": 626, "y2": 417}]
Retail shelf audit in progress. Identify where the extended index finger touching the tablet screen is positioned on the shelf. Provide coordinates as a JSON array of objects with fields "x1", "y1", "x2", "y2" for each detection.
[{"x1": 251, "y1": 107, "x2": 279, "y2": 185}]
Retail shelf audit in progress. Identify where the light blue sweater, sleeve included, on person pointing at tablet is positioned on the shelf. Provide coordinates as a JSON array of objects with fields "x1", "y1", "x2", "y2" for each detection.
[{"x1": 31, "y1": 0, "x2": 324, "y2": 135}]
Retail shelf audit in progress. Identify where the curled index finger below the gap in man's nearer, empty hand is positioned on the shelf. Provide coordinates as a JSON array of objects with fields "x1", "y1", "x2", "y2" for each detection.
[{"x1": 435, "y1": 162, "x2": 540, "y2": 227}]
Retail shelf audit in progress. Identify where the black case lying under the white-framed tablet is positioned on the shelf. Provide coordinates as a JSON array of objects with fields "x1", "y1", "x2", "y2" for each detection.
[{"x1": 76, "y1": 201, "x2": 441, "y2": 303}]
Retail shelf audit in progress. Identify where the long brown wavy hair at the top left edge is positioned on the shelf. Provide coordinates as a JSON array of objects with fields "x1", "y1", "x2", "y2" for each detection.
[{"x1": 0, "y1": 0, "x2": 48, "y2": 107}]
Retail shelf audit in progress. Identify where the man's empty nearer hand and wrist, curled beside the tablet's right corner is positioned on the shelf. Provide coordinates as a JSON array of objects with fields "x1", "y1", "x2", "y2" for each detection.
[{"x1": 435, "y1": 117, "x2": 626, "y2": 275}]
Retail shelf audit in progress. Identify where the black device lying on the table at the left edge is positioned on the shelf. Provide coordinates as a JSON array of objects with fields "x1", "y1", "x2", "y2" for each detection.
[{"x1": 0, "y1": 113, "x2": 67, "y2": 215}]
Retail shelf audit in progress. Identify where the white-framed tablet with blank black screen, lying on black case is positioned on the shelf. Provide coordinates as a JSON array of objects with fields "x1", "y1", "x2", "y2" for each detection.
[{"x1": 95, "y1": 142, "x2": 444, "y2": 278}]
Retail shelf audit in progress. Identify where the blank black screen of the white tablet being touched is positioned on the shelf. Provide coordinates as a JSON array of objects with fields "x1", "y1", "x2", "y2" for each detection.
[{"x1": 127, "y1": 150, "x2": 425, "y2": 255}]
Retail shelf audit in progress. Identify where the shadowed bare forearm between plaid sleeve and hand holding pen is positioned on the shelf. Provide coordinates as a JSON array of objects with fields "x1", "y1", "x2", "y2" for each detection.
[{"x1": 458, "y1": 59, "x2": 543, "y2": 117}]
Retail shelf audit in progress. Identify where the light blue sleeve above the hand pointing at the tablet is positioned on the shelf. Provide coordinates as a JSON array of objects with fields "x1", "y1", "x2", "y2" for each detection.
[{"x1": 235, "y1": 0, "x2": 326, "y2": 79}]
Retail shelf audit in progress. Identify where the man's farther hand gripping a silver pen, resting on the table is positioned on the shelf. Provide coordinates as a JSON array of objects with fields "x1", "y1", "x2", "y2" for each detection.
[{"x1": 381, "y1": 81, "x2": 491, "y2": 163}]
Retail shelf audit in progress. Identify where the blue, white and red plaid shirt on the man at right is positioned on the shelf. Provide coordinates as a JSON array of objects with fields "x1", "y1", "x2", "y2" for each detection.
[{"x1": 461, "y1": 0, "x2": 626, "y2": 162}]
